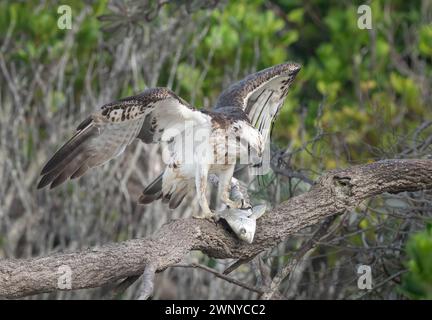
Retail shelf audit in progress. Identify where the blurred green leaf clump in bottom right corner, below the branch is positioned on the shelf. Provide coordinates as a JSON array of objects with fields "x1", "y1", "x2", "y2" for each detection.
[{"x1": 400, "y1": 224, "x2": 432, "y2": 300}]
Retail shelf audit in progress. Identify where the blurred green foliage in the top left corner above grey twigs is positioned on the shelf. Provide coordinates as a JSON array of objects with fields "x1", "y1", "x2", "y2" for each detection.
[{"x1": 0, "y1": 1, "x2": 108, "y2": 95}]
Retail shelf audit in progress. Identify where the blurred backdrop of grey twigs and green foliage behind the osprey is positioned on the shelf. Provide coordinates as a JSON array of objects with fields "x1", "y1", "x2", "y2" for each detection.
[{"x1": 0, "y1": 0, "x2": 432, "y2": 299}]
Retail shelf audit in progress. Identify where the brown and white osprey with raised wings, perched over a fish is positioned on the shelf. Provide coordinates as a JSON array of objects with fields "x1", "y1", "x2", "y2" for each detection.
[{"x1": 38, "y1": 63, "x2": 300, "y2": 218}]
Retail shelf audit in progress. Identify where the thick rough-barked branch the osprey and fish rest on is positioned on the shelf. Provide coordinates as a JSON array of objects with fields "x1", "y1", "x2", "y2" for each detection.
[{"x1": 0, "y1": 160, "x2": 432, "y2": 298}]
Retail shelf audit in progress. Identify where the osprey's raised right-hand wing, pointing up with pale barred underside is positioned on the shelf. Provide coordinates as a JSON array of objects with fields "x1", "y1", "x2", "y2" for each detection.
[{"x1": 214, "y1": 63, "x2": 301, "y2": 141}]
